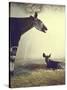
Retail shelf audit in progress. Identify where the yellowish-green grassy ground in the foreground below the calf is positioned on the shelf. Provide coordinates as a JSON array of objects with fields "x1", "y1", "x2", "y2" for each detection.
[{"x1": 11, "y1": 69, "x2": 65, "y2": 87}]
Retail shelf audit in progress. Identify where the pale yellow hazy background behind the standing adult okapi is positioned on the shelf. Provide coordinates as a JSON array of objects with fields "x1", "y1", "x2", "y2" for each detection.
[{"x1": 11, "y1": 4, "x2": 65, "y2": 64}]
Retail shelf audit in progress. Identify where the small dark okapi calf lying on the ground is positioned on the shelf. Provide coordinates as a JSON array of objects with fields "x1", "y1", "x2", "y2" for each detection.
[{"x1": 43, "y1": 53, "x2": 62, "y2": 69}]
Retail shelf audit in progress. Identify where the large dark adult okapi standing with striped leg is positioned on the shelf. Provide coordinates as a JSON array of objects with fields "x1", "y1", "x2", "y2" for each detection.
[{"x1": 9, "y1": 12, "x2": 47, "y2": 75}]
